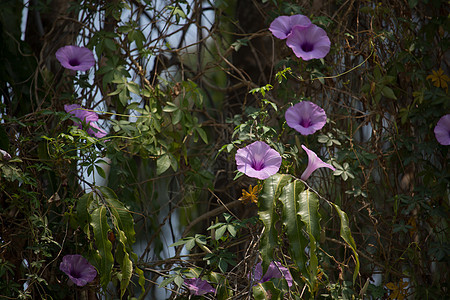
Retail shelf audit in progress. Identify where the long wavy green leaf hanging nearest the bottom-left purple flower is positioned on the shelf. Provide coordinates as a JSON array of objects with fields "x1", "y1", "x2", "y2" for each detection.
[{"x1": 91, "y1": 206, "x2": 114, "y2": 288}]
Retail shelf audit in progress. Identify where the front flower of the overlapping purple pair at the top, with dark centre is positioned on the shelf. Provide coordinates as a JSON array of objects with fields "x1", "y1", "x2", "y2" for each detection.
[{"x1": 286, "y1": 24, "x2": 331, "y2": 60}]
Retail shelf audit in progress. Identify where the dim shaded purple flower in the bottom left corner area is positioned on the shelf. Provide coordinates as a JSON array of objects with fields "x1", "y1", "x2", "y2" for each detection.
[{"x1": 59, "y1": 254, "x2": 97, "y2": 286}]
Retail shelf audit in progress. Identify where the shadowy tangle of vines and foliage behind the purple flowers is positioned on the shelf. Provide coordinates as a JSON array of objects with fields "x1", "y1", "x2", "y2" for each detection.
[{"x1": 0, "y1": 0, "x2": 450, "y2": 299}]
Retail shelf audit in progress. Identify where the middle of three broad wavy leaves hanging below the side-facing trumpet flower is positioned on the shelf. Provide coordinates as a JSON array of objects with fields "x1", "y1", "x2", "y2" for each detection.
[{"x1": 280, "y1": 180, "x2": 308, "y2": 274}]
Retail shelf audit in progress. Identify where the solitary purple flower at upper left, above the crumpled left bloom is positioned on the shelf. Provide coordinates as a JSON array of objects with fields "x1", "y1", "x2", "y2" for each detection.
[{"x1": 55, "y1": 46, "x2": 95, "y2": 71}]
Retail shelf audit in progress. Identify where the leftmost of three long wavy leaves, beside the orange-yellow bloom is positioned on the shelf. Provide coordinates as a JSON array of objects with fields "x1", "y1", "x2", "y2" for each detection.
[{"x1": 258, "y1": 174, "x2": 292, "y2": 271}]
